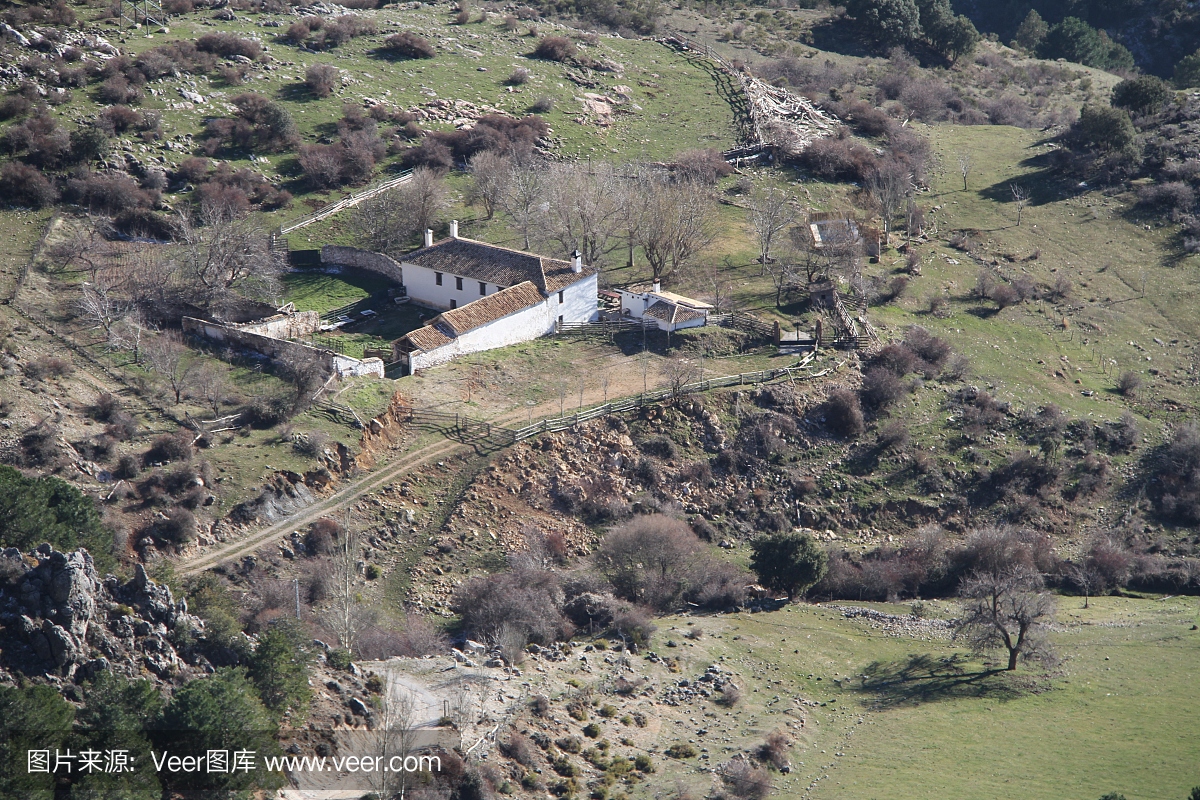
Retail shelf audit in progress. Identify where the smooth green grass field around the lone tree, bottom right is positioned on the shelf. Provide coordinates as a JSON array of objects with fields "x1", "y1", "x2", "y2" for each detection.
[{"x1": 654, "y1": 597, "x2": 1200, "y2": 800}]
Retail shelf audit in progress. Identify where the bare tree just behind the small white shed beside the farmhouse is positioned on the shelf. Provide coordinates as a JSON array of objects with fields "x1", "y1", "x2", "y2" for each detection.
[{"x1": 637, "y1": 178, "x2": 716, "y2": 281}]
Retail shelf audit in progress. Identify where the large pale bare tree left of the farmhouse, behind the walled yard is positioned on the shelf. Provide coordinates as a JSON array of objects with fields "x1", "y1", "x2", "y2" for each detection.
[{"x1": 180, "y1": 207, "x2": 287, "y2": 307}]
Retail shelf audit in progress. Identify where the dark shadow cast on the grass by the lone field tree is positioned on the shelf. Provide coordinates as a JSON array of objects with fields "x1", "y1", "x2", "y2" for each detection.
[{"x1": 857, "y1": 654, "x2": 1027, "y2": 708}]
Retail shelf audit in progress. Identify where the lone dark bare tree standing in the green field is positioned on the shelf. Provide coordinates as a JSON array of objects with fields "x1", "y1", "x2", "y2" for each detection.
[{"x1": 954, "y1": 566, "x2": 1055, "y2": 670}]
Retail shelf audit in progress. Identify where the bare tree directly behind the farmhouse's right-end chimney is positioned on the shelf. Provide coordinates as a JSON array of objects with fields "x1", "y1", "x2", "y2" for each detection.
[{"x1": 544, "y1": 162, "x2": 622, "y2": 265}]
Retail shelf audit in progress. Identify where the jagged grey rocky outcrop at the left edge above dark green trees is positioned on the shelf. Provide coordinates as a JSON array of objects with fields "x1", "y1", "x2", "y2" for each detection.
[{"x1": 0, "y1": 545, "x2": 204, "y2": 681}]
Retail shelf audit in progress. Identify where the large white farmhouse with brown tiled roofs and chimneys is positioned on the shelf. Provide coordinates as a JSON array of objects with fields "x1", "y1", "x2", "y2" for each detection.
[{"x1": 392, "y1": 222, "x2": 598, "y2": 373}]
